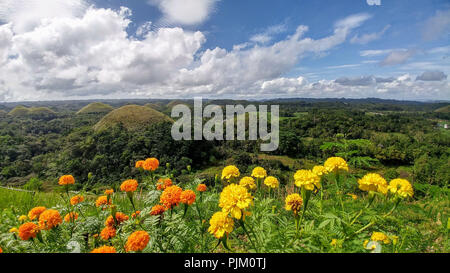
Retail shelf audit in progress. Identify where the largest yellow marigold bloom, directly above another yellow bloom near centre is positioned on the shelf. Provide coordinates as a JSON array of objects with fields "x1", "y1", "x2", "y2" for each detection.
[{"x1": 219, "y1": 184, "x2": 253, "y2": 219}]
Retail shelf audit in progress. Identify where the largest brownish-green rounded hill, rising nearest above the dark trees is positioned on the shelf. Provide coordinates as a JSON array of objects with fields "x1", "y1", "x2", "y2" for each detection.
[{"x1": 94, "y1": 105, "x2": 173, "y2": 131}]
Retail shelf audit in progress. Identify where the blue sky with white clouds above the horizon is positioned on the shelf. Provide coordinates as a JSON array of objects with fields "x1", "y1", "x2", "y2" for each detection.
[{"x1": 0, "y1": 0, "x2": 450, "y2": 102}]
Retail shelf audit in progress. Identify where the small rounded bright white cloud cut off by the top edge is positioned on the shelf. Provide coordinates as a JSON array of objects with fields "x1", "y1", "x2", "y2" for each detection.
[{"x1": 148, "y1": 0, "x2": 219, "y2": 25}]
